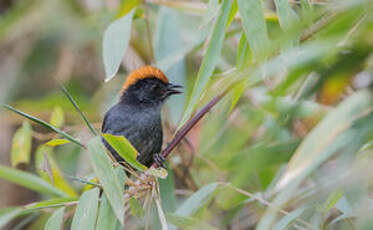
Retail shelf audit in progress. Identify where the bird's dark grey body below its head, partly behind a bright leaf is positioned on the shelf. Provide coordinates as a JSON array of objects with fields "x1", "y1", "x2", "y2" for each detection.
[{"x1": 102, "y1": 104, "x2": 163, "y2": 166}]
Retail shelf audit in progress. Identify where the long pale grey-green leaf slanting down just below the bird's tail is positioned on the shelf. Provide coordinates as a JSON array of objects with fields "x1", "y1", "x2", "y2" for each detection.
[{"x1": 88, "y1": 137, "x2": 124, "y2": 226}]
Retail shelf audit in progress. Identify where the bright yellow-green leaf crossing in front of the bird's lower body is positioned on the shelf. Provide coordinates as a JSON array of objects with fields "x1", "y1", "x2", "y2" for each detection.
[{"x1": 102, "y1": 134, "x2": 147, "y2": 171}]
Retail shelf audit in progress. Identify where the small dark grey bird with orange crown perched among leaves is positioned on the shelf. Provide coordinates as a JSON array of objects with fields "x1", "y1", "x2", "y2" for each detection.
[{"x1": 101, "y1": 66, "x2": 182, "y2": 167}]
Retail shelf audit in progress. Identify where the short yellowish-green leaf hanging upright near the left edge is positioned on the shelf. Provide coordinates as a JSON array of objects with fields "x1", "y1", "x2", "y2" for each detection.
[{"x1": 11, "y1": 121, "x2": 32, "y2": 167}]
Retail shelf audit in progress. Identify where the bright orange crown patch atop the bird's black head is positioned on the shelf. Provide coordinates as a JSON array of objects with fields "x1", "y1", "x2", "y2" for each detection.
[{"x1": 122, "y1": 66, "x2": 168, "y2": 93}]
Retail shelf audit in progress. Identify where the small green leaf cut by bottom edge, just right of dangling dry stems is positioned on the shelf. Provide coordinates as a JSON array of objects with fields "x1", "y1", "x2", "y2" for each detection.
[{"x1": 166, "y1": 213, "x2": 217, "y2": 230}]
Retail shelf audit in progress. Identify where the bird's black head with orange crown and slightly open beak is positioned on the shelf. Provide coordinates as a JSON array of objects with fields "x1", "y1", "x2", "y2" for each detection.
[{"x1": 121, "y1": 67, "x2": 181, "y2": 105}]
